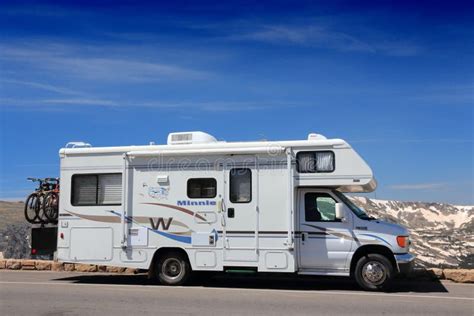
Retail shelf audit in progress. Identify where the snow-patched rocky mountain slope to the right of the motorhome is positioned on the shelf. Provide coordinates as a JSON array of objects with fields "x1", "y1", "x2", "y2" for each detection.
[{"x1": 352, "y1": 197, "x2": 474, "y2": 268}]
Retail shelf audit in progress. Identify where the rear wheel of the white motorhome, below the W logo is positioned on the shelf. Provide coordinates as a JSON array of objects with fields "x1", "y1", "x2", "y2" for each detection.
[{"x1": 155, "y1": 251, "x2": 191, "y2": 285}]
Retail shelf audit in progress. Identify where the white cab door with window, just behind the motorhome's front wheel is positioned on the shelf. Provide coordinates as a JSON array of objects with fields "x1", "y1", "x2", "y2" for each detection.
[{"x1": 298, "y1": 189, "x2": 354, "y2": 272}]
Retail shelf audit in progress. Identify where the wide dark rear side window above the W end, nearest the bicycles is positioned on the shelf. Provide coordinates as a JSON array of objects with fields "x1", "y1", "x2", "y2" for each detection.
[{"x1": 71, "y1": 173, "x2": 122, "y2": 206}]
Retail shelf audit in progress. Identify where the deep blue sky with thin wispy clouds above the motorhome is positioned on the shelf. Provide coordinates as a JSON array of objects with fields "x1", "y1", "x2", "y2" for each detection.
[{"x1": 0, "y1": 1, "x2": 474, "y2": 204}]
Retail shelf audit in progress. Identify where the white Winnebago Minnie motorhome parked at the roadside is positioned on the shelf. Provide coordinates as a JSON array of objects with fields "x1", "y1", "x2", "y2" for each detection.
[{"x1": 57, "y1": 132, "x2": 414, "y2": 290}]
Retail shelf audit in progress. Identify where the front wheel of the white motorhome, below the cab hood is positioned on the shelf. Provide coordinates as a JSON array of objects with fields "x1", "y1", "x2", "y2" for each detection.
[{"x1": 354, "y1": 254, "x2": 394, "y2": 291}]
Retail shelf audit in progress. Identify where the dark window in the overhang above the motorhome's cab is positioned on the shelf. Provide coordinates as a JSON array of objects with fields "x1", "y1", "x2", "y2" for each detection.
[{"x1": 296, "y1": 151, "x2": 335, "y2": 173}]
